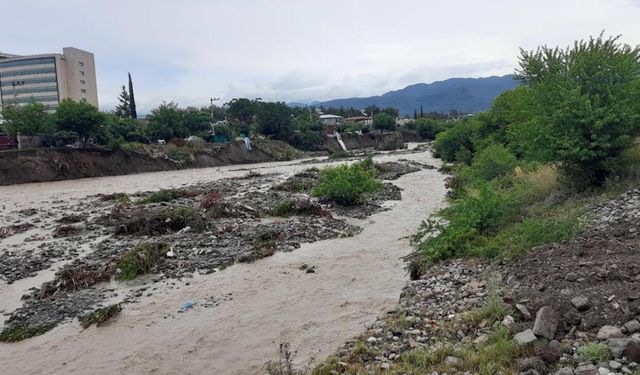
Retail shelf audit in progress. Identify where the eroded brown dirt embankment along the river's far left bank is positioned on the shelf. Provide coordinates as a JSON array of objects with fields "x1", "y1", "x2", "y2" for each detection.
[{"x1": 0, "y1": 141, "x2": 296, "y2": 185}]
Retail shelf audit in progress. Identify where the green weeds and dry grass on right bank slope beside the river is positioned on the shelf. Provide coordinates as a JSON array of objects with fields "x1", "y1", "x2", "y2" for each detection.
[{"x1": 412, "y1": 159, "x2": 580, "y2": 268}]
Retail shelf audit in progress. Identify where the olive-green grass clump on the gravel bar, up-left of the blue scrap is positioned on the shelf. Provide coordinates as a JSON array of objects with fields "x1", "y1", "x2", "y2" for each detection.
[{"x1": 116, "y1": 242, "x2": 169, "y2": 280}]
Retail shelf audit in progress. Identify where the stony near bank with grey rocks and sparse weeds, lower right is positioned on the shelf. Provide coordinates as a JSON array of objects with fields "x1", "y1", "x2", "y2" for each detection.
[{"x1": 320, "y1": 189, "x2": 640, "y2": 375}]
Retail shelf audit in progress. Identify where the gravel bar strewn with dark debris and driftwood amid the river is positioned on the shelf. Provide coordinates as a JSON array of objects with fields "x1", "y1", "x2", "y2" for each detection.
[{"x1": 0, "y1": 156, "x2": 430, "y2": 338}]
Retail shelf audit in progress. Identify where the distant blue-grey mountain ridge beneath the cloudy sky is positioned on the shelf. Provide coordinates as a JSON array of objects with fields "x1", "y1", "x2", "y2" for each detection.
[{"x1": 314, "y1": 75, "x2": 518, "y2": 115}]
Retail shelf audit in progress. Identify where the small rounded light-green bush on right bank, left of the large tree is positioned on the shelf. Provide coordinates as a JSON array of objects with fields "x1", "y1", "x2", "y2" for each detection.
[{"x1": 471, "y1": 144, "x2": 517, "y2": 181}]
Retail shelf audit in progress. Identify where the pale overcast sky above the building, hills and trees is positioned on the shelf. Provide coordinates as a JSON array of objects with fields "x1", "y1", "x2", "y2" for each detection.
[{"x1": 0, "y1": 0, "x2": 640, "y2": 113}]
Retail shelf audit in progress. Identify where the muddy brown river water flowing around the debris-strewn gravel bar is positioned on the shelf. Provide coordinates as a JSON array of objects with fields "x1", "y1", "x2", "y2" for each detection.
[{"x1": 0, "y1": 148, "x2": 446, "y2": 374}]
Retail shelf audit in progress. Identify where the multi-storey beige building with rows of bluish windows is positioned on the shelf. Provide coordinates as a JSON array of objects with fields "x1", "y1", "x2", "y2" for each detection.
[{"x1": 0, "y1": 47, "x2": 98, "y2": 114}]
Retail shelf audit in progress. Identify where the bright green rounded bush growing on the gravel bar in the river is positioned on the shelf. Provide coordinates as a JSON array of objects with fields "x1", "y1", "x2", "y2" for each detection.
[{"x1": 312, "y1": 163, "x2": 382, "y2": 206}]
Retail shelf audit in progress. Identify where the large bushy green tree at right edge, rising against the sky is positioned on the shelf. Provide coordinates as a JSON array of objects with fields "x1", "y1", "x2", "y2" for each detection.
[{"x1": 510, "y1": 35, "x2": 640, "y2": 186}]
